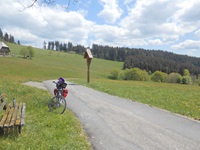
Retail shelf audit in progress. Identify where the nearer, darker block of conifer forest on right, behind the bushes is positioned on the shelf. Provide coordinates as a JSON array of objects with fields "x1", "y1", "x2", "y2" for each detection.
[{"x1": 123, "y1": 50, "x2": 200, "y2": 75}]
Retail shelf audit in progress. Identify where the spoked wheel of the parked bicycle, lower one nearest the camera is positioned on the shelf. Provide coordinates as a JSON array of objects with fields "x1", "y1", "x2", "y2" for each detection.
[{"x1": 48, "y1": 96, "x2": 67, "y2": 114}]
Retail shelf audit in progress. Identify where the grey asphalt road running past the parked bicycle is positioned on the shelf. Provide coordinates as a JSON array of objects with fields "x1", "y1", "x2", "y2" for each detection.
[{"x1": 44, "y1": 81, "x2": 200, "y2": 150}]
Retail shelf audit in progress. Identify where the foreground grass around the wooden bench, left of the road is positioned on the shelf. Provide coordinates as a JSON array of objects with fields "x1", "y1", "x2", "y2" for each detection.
[{"x1": 0, "y1": 80, "x2": 91, "y2": 150}]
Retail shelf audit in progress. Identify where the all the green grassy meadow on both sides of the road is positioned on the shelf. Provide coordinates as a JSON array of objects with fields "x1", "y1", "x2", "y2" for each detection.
[{"x1": 0, "y1": 43, "x2": 200, "y2": 150}]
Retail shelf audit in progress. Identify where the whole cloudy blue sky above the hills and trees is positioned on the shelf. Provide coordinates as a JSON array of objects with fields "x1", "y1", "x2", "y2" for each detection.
[{"x1": 0, "y1": 0, "x2": 200, "y2": 57}]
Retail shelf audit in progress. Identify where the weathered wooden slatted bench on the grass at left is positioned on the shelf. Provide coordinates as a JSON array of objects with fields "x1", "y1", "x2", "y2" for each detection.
[{"x1": 0, "y1": 97, "x2": 26, "y2": 134}]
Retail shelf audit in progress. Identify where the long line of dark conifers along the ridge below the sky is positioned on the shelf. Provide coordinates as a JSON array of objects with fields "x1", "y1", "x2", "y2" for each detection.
[{"x1": 44, "y1": 41, "x2": 200, "y2": 75}]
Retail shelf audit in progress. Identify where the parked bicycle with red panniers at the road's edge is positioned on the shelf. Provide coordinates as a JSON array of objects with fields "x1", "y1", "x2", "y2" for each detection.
[{"x1": 48, "y1": 81, "x2": 68, "y2": 114}]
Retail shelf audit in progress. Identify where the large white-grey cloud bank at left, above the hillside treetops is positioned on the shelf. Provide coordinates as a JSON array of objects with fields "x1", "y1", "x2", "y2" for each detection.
[{"x1": 0, "y1": 0, "x2": 93, "y2": 47}]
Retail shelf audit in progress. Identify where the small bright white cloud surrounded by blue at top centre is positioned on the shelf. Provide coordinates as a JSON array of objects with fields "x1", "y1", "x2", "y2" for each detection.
[{"x1": 98, "y1": 0, "x2": 122, "y2": 23}]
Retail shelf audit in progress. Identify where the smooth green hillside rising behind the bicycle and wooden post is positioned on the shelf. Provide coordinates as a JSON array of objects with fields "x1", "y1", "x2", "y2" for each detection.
[{"x1": 0, "y1": 43, "x2": 123, "y2": 81}]
